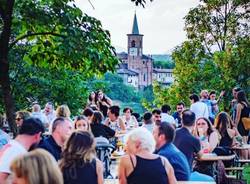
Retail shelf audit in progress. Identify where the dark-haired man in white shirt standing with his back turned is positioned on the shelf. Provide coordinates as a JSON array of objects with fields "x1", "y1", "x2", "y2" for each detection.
[{"x1": 189, "y1": 94, "x2": 209, "y2": 120}]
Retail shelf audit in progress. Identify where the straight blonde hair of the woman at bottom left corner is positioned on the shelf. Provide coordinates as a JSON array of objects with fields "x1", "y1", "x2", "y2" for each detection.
[{"x1": 10, "y1": 149, "x2": 63, "y2": 184}]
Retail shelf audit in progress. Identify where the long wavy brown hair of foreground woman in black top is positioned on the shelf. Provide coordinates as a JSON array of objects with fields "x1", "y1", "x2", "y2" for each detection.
[{"x1": 59, "y1": 130, "x2": 96, "y2": 170}]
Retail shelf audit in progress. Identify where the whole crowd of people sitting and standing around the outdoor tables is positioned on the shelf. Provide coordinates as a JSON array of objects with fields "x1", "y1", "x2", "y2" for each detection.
[{"x1": 0, "y1": 88, "x2": 250, "y2": 184}]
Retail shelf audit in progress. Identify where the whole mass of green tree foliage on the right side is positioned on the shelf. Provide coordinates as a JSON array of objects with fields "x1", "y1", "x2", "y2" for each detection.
[{"x1": 151, "y1": 0, "x2": 250, "y2": 108}]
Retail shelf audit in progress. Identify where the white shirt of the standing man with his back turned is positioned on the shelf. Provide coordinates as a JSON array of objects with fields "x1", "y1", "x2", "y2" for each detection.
[{"x1": 190, "y1": 102, "x2": 209, "y2": 119}]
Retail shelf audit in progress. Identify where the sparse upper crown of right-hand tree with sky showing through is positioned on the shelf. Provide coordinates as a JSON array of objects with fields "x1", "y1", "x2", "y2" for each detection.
[{"x1": 184, "y1": 0, "x2": 250, "y2": 54}]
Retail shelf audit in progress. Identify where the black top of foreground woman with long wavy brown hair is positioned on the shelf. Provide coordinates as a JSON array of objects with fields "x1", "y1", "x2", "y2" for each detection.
[{"x1": 63, "y1": 159, "x2": 97, "y2": 184}]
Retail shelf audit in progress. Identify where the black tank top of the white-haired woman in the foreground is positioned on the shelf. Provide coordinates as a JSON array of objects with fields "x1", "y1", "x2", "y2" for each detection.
[{"x1": 127, "y1": 155, "x2": 168, "y2": 184}]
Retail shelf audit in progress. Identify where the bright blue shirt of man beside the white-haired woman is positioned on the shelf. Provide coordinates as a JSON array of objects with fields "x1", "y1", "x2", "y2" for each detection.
[{"x1": 155, "y1": 143, "x2": 190, "y2": 181}]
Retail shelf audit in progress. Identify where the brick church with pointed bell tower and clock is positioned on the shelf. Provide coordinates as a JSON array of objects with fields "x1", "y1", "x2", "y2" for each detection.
[{"x1": 117, "y1": 14, "x2": 172, "y2": 89}]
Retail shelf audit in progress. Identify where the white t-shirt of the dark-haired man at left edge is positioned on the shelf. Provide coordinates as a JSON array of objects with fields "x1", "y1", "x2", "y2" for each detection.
[{"x1": 0, "y1": 140, "x2": 27, "y2": 174}]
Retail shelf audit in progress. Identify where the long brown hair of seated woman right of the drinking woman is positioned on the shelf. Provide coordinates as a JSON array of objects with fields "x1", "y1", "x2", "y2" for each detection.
[{"x1": 214, "y1": 112, "x2": 233, "y2": 137}]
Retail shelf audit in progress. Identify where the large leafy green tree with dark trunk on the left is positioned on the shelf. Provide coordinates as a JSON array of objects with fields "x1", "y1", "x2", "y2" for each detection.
[{"x1": 0, "y1": 0, "x2": 118, "y2": 132}]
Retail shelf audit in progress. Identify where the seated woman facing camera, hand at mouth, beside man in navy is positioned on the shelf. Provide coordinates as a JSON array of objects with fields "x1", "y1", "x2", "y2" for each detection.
[{"x1": 194, "y1": 117, "x2": 219, "y2": 153}]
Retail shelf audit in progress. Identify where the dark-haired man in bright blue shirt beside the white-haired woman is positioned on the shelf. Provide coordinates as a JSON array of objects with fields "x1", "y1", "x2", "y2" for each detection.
[{"x1": 153, "y1": 122, "x2": 190, "y2": 181}]
